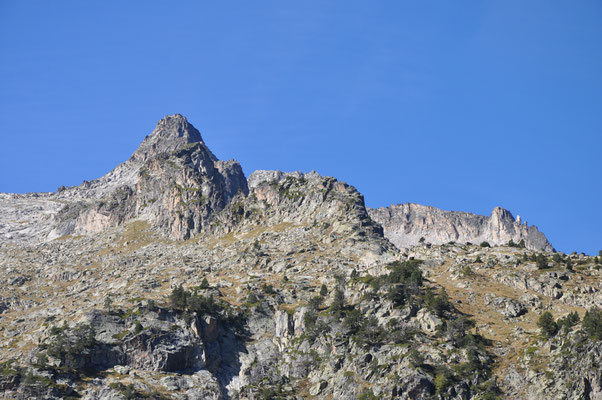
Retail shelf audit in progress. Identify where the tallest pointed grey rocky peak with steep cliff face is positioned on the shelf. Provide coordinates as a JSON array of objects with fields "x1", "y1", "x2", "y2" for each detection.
[{"x1": 50, "y1": 115, "x2": 248, "y2": 239}]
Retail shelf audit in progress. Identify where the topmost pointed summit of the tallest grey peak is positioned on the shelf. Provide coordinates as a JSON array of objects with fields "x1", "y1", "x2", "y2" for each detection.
[{"x1": 132, "y1": 114, "x2": 217, "y2": 161}]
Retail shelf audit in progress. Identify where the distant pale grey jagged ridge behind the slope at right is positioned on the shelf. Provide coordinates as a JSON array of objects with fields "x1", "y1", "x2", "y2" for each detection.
[{"x1": 368, "y1": 203, "x2": 554, "y2": 251}]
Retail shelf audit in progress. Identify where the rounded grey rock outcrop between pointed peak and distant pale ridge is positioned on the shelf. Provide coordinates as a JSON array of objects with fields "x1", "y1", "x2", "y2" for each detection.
[{"x1": 216, "y1": 171, "x2": 394, "y2": 265}]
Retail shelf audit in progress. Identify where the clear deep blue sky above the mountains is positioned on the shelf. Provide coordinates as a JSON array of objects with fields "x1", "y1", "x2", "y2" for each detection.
[{"x1": 0, "y1": 0, "x2": 602, "y2": 254}]
